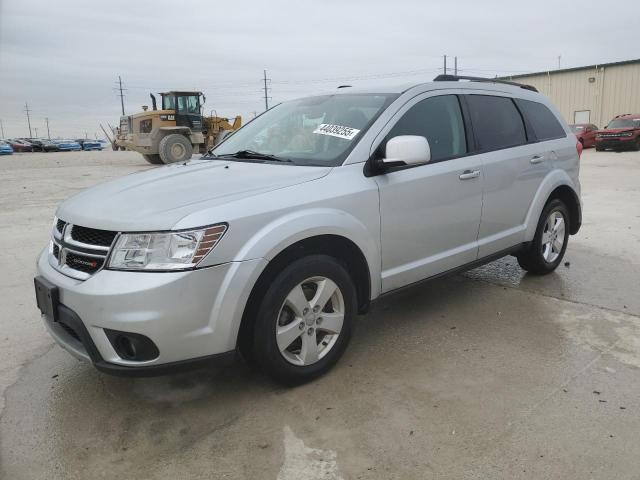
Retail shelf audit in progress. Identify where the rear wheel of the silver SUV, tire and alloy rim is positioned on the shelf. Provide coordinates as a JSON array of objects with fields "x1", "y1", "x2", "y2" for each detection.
[{"x1": 517, "y1": 198, "x2": 569, "y2": 275}]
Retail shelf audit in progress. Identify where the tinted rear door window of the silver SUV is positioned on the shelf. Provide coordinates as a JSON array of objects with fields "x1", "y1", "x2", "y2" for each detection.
[{"x1": 466, "y1": 95, "x2": 527, "y2": 151}]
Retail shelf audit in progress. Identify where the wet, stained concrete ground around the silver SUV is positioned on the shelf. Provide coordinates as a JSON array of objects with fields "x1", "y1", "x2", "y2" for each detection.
[{"x1": 0, "y1": 150, "x2": 640, "y2": 480}]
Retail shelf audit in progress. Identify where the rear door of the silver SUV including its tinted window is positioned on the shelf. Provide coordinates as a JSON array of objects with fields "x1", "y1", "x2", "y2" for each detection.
[{"x1": 465, "y1": 90, "x2": 553, "y2": 258}]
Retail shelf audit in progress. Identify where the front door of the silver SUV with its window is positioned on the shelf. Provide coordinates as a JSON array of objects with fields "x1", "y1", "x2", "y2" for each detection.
[{"x1": 374, "y1": 92, "x2": 483, "y2": 292}]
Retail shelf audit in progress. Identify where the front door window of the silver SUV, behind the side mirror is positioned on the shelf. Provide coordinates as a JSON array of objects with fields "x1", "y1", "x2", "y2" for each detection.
[{"x1": 385, "y1": 95, "x2": 467, "y2": 162}]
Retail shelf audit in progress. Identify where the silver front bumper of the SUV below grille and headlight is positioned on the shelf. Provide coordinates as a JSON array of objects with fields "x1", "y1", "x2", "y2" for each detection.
[{"x1": 37, "y1": 250, "x2": 266, "y2": 375}]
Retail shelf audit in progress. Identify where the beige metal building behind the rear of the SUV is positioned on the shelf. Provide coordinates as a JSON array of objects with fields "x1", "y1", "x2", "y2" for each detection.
[{"x1": 507, "y1": 59, "x2": 640, "y2": 127}]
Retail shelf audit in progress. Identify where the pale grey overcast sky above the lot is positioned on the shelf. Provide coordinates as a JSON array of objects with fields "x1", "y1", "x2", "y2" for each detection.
[{"x1": 0, "y1": 0, "x2": 640, "y2": 138}]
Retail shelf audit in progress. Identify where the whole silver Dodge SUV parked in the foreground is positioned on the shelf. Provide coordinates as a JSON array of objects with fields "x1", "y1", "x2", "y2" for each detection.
[{"x1": 35, "y1": 76, "x2": 581, "y2": 383}]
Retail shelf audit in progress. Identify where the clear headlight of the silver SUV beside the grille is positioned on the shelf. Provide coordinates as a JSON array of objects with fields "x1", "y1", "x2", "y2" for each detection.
[{"x1": 107, "y1": 224, "x2": 227, "y2": 270}]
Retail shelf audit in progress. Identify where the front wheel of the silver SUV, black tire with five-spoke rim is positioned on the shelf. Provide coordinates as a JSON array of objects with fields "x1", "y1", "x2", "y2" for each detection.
[{"x1": 252, "y1": 255, "x2": 357, "y2": 385}]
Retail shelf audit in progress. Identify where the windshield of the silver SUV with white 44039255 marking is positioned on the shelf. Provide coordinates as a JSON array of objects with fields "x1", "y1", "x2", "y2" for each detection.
[{"x1": 212, "y1": 94, "x2": 397, "y2": 166}]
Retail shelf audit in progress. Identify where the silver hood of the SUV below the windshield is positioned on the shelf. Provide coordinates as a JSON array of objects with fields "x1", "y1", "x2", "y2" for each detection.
[{"x1": 56, "y1": 160, "x2": 331, "y2": 231}]
